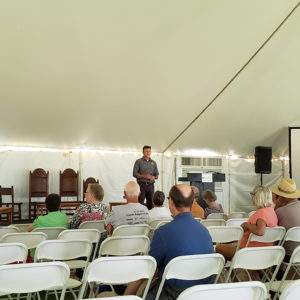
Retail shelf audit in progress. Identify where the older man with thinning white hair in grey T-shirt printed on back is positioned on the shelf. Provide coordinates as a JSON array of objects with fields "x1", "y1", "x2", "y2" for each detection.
[{"x1": 105, "y1": 181, "x2": 148, "y2": 234}]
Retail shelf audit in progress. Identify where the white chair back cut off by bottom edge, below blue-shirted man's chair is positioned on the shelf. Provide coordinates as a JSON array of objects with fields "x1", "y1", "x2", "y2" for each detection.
[{"x1": 177, "y1": 281, "x2": 267, "y2": 300}]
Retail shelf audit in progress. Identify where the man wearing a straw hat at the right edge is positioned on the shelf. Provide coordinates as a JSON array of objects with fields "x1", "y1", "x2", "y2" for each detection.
[{"x1": 272, "y1": 178, "x2": 300, "y2": 261}]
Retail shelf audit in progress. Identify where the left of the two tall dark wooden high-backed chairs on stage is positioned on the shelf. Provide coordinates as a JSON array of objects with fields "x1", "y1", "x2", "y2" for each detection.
[{"x1": 29, "y1": 168, "x2": 49, "y2": 220}]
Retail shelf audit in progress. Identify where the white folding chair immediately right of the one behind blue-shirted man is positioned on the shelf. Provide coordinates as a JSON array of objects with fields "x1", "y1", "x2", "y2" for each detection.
[{"x1": 226, "y1": 246, "x2": 285, "y2": 285}]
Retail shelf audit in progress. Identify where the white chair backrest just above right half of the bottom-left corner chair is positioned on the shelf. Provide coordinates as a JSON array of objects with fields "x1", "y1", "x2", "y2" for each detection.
[{"x1": 34, "y1": 240, "x2": 92, "y2": 262}]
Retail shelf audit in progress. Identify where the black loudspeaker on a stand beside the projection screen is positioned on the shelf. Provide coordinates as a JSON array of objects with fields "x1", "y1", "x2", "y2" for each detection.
[{"x1": 255, "y1": 146, "x2": 272, "y2": 174}]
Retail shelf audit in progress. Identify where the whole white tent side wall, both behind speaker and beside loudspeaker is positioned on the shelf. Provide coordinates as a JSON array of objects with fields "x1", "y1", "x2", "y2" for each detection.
[{"x1": 0, "y1": 151, "x2": 288, "y2": 218}]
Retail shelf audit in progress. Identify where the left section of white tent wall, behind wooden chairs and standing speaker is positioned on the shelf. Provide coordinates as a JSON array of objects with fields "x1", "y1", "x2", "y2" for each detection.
[{"x1": 0, "y1": 151, "x2": 174, "y2": 218}]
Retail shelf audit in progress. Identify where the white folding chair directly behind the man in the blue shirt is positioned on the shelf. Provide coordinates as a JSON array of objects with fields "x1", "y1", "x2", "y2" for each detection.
[{"x1": 155, "y1": 253, "x2": 225, "y2": 300}]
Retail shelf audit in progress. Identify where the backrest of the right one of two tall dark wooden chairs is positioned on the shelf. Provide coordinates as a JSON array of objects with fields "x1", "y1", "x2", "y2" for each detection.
[{"x1": 59, "y1": 169, "x2": 79, "y2": 201}]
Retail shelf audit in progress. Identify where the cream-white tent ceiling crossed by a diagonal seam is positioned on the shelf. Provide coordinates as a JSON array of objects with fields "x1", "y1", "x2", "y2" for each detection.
[{"x1": 0, "y1": 0, "x2": 300, "y2": 155}]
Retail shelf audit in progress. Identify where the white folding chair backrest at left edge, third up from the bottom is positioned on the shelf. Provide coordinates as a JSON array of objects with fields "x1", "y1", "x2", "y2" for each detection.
[{"x1": 0, "y1": 232, "x2": 47, "y2": 249}]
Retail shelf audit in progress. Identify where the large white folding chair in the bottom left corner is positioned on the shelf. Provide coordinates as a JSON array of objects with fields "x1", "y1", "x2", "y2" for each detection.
[{"x1": 0, "y1": 262, "x2": 70, "y2": 300}]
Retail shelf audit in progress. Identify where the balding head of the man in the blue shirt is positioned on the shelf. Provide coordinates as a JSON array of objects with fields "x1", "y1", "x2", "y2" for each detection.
[{"x1": 169, "y1": 184, "x2": 194, "y2": 209}]
